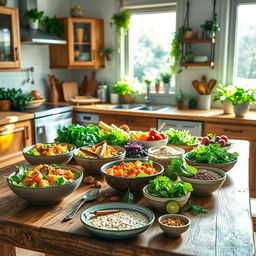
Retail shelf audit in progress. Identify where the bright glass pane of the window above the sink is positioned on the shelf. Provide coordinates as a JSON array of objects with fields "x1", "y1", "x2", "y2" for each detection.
[{"x1": 129, "y1": 12, "x2": 176, "y2": 82}]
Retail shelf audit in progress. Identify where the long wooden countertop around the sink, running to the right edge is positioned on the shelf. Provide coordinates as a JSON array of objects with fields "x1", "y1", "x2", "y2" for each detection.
[{"x1": 74, "y1": 104, "x2": 256, "y2": 125}]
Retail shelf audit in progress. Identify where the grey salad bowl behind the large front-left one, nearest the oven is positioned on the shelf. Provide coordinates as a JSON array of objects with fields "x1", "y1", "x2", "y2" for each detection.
[{"x1": 22, "y1": 143, "x2": 76, "y2": 165}]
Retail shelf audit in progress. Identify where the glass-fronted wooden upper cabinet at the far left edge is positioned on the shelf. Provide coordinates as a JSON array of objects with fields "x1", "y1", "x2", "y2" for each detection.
[{"x1": 0, "y1": 6, "x2": 20, "y2": 71}]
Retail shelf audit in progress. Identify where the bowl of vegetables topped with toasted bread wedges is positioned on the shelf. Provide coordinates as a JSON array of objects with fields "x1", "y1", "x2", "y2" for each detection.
[{"x1": 74, "y1": 141, "x2": 126, "y2": 176}]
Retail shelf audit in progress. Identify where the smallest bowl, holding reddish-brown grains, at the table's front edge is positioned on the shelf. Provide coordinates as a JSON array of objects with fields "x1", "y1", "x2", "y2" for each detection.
[{"x1": 158, "y1": 214, "x2": 190, "y2": 237}]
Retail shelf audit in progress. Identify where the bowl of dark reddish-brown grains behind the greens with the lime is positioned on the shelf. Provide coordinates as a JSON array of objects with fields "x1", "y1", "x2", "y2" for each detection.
[{"x1": 180, "y1": 166, "x2": 226, "y2": 196}]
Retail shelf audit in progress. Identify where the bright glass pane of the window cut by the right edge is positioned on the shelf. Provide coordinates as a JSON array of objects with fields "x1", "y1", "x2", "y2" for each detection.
[{"x1": 233, "y1": 4, "x2": 256, "y2": 88}]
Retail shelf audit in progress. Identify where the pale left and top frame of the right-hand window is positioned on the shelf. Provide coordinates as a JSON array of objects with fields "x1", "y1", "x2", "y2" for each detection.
[{"x1": 226, "y1": 0, "x2": 256, "y2": 84}]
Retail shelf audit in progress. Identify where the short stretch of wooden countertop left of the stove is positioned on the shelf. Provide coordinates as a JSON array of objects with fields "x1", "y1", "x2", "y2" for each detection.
[{"x1": 0, "y1": 111, "x2": 34, "y2": 125}]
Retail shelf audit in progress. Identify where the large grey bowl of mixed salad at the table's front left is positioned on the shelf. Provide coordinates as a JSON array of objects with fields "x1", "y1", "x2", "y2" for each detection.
[{"x1": 7, "y1": 164, "x2": 83, "y2": 205}]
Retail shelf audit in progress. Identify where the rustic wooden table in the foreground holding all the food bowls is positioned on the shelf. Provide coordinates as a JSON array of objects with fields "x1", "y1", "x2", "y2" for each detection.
[{"x1": 0, "y1": 142, "x2": 254, "y2": 256}]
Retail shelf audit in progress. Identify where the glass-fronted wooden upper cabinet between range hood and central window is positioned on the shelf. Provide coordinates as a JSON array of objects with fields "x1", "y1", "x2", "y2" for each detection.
[{"x1": 50, "y1": 18, "x2": 104, "y2": 69}]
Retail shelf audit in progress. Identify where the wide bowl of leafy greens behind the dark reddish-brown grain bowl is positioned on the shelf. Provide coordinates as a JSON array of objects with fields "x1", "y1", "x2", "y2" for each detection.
[{"x1": 185, "y1": 144, "x2": 238, "y2": 172}]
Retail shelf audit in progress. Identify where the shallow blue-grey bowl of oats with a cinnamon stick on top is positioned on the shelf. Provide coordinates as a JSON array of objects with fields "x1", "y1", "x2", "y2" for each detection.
[{"x1": 80, "y1": 203, "x2": 155, "y2": 239}]
